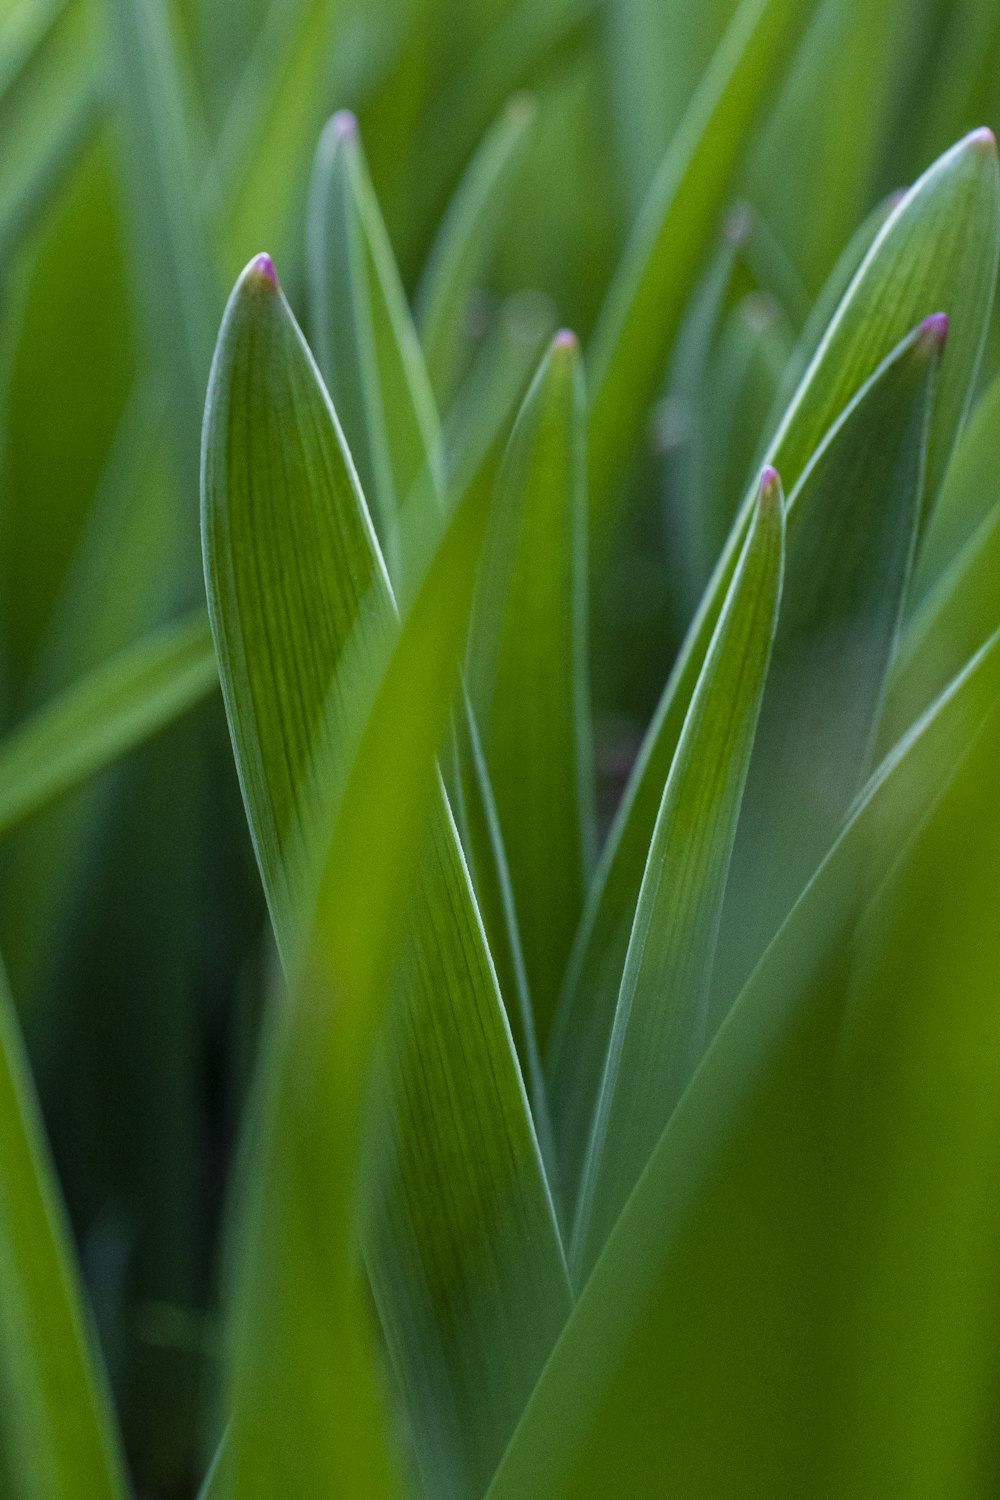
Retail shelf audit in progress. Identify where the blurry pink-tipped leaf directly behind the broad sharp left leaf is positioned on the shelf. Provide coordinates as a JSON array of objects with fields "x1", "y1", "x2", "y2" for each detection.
[{"x1": 309, "y1": 111, "x2": 444, "y2": 581}]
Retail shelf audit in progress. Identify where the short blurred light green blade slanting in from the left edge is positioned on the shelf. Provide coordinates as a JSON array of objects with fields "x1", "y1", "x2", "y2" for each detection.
[{"x1": 0, "y1": 612, "x2": 217, "y2": 837}]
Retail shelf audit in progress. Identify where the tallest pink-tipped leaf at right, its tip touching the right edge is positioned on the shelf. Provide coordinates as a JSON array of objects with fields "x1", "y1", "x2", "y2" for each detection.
[{"x1": 547, "y1": 132, "x2": 1000, "y2": 1206}]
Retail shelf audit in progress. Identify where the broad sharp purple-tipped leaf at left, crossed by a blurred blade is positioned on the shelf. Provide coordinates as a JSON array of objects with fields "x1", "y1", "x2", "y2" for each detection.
[{"x1": 204, "y1": 258, "x2": 570, "y2": 1496}]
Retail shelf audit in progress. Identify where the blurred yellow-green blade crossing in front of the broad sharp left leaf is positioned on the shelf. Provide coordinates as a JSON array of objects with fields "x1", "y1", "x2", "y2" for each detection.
[{"x1": 225, "y1": 450, "x2": 497, "y2": 1500}]
